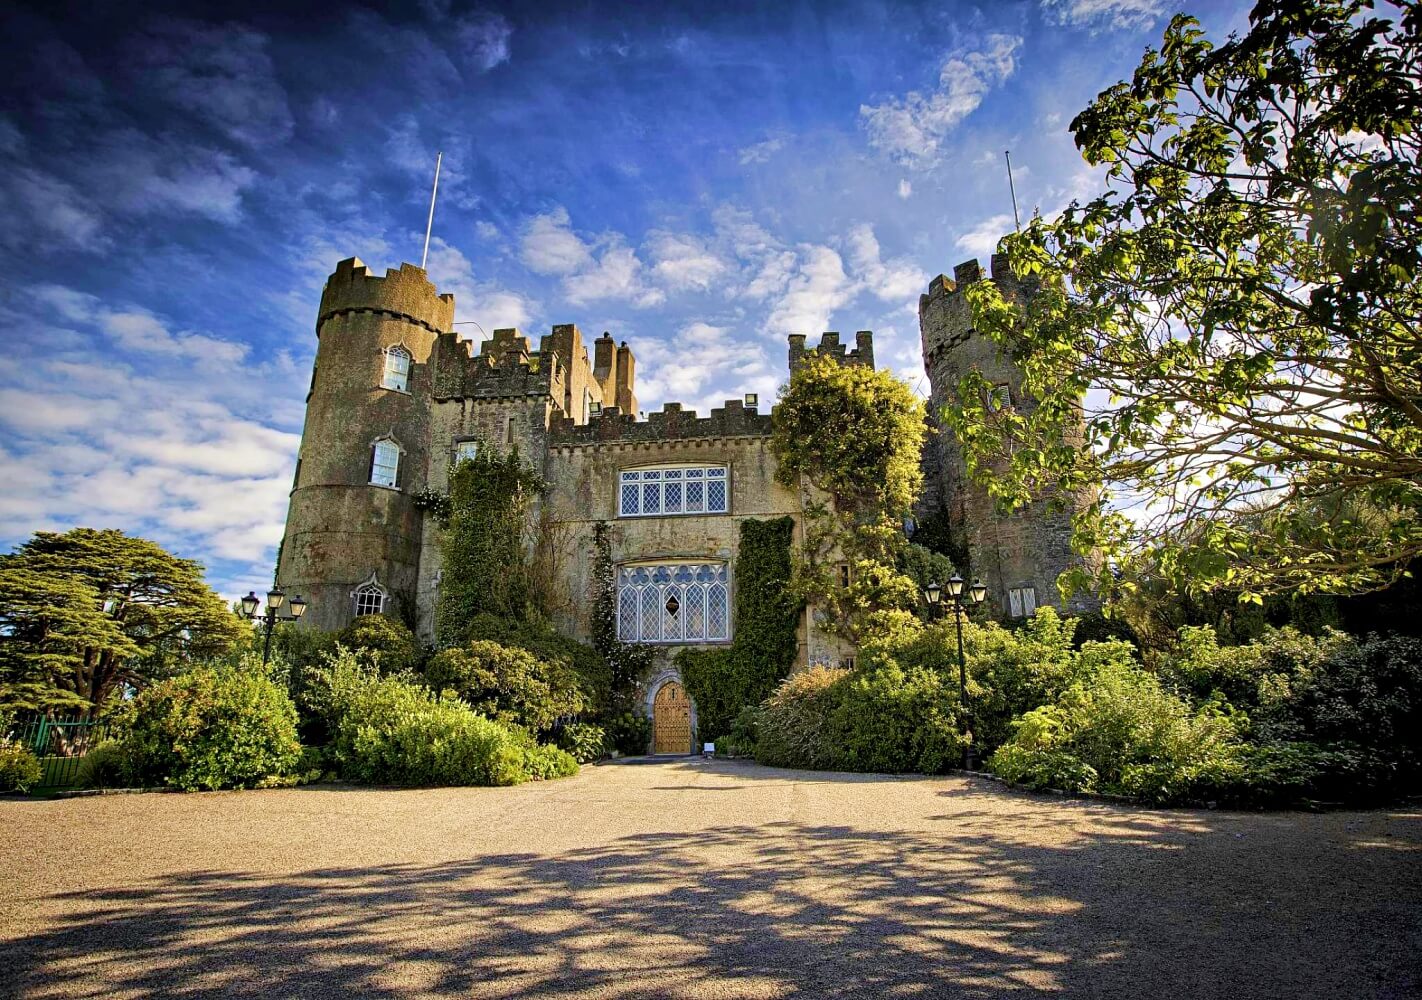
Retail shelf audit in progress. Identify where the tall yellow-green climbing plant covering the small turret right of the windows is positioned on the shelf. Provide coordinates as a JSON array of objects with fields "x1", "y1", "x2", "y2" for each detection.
[{"x1": 771, "y1": 354, "x2": 924, "y2": 643}]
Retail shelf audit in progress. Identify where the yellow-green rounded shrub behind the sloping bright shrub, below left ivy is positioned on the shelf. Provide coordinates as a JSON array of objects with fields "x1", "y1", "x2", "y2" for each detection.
[{"x1": 424, "y1": 639, "x2": 583, "y2": 733}]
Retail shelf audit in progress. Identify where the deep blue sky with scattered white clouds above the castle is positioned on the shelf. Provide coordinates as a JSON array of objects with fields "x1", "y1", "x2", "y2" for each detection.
[{"x1": 0, "y1": 0, "x2": 1249, "y2": 595}]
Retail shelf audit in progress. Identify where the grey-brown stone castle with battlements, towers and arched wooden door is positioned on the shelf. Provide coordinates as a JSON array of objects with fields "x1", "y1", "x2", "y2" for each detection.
[{"x1": 277, "y1": 251, "x2": 1072, "y2": 752}]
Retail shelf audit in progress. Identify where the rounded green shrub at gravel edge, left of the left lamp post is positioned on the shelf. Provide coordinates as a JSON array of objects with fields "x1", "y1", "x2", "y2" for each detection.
[{"x1": 124, "y1": 667, "x2": 301, "y2": 791}]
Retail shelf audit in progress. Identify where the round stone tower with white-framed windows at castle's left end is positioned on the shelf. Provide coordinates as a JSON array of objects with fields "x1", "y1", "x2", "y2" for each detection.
[{"x1": 277, "y1": 257, "x2": 454, "y2": 630}]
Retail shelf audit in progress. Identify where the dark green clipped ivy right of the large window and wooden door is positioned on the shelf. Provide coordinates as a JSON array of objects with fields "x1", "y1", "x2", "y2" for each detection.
[{"x1": 677, "y1": 518, "x2": 802, "y2": 740}]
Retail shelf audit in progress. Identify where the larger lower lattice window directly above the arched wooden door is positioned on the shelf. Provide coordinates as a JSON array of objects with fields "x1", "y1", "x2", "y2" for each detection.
[{"x1": 617, "y1": 562, "x2": 731, "y2": 643}]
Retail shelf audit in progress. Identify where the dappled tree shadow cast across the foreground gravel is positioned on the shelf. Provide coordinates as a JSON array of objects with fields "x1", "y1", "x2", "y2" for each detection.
[{"x1": 0, "y1": 785, "x2": 1422, "y2": 999}]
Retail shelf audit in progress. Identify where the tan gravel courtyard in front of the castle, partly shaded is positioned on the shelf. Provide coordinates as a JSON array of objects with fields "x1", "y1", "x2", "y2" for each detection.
[{"x1": 0, "y1": 761, "x2": 1422, "y2": 1000}]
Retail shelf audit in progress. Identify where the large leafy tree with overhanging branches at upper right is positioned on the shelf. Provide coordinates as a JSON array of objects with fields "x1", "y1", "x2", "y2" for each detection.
[{"x1": 944, "y1": 0, "x2": 1422, "y2": 602}]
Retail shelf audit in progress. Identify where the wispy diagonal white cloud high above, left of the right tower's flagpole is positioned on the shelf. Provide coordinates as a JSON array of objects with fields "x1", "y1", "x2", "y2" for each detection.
[{"x1": 859, "y1": 34, "x2": 1022, "y2": 168}]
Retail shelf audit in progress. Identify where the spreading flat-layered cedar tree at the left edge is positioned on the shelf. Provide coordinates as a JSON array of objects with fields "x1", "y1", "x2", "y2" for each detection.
[{"x1": 0, "y1": 528, "x2": 243, "y2": 713}]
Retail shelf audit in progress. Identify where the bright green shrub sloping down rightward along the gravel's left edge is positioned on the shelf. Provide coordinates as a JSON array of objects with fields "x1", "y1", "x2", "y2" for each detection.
[{"x1": 328, "y1": 654, "x2": 577, "y2": 785}]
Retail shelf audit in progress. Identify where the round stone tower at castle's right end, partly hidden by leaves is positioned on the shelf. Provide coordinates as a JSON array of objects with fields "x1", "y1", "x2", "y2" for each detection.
[{"x1": 919, "y1": 255, "x2": 1091, "y2": 617}]
